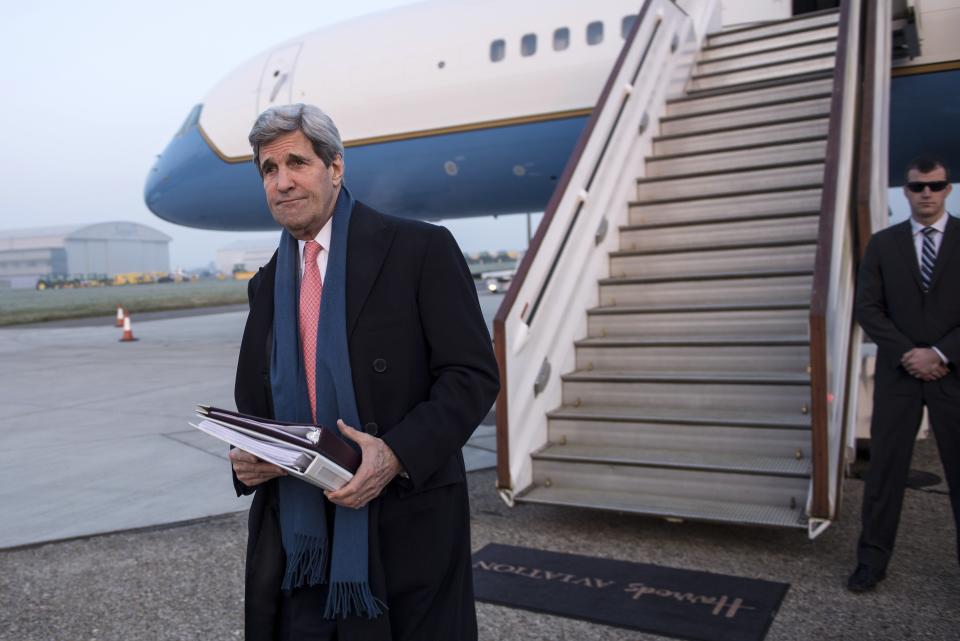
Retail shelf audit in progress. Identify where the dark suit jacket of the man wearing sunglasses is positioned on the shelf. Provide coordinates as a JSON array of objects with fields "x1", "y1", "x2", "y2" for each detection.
[{"x1": 856, "y1": 216, "x2": 960, "y2": 396}]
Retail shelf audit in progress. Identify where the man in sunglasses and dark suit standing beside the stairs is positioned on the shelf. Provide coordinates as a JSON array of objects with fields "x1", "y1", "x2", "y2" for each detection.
[{"x1": 847, "y1": 158, "x2": 960, "y2": 592}]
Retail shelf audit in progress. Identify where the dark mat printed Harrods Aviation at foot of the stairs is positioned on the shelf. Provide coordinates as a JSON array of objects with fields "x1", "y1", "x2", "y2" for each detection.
[{"x1": 473, "y1": 543, "x2": 790, "y2": 641}]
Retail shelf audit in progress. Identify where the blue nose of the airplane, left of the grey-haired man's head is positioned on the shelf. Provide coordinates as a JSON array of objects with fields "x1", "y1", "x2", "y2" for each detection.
[{"x1": 143, "y1": 105, "x2": 276, "y2": 230}]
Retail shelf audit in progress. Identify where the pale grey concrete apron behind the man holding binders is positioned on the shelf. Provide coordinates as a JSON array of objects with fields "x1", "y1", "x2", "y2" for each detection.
[{"x1": 0, "y1": 296, "x2": 502, "y2": 552}]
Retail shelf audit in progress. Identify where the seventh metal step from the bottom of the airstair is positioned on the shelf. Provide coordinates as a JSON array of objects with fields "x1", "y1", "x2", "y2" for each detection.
[{"x1": 600, "y1": 271, "x2": 813, "y2": 307}]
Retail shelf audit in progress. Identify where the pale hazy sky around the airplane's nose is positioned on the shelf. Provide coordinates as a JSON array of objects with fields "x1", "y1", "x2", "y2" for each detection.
[{"x1": 0, "y1": 0, "x2": 540, "y2": 268}]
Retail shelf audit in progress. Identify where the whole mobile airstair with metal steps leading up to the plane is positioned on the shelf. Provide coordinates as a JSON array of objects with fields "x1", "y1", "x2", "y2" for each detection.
[{"x1": 495, "y1": 0, "x2": 890, "y2": 536}]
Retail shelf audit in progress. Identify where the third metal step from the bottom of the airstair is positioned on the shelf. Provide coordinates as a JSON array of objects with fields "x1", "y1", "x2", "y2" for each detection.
[{"x1": 548, "y1": 417, "x2": 810, "y2": 460}]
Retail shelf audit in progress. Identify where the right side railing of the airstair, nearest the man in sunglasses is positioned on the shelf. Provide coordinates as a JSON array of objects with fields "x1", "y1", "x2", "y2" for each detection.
[{"x1": 807, "y1": 0, "x2": 889, "y2": 538}]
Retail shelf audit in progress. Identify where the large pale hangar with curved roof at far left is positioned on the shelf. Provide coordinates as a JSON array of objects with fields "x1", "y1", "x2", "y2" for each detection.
[{"x1": 0, "y1": 221, "x2": 172, "y2": 288}]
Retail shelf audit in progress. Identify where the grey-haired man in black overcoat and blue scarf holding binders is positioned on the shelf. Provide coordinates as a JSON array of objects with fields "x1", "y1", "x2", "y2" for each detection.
[{"x1": 231, "y1": 105, "x2": 499, "y2": 641}]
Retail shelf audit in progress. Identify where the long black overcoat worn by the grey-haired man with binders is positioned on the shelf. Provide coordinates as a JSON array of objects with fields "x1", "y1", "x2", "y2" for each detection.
[{"x1": 234, "y1": 202, "x2": 499, "y2": 641}]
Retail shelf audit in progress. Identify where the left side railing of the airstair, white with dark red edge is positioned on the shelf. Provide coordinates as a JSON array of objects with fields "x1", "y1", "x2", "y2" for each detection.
[{"x1": 493, "y1": 0, "x2": 717, "y2": 503}]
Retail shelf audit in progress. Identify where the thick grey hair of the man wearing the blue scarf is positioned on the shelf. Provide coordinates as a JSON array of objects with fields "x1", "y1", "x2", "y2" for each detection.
[{"x1": 248, "y1": 103, "x2": 343, "y2": 171}]
